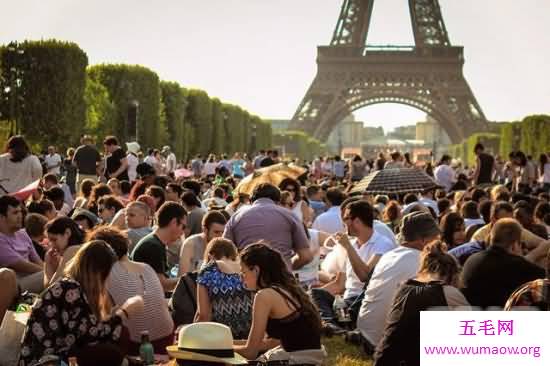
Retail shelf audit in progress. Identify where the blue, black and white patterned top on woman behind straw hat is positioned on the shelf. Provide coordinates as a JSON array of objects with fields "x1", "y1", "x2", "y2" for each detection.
[{"x1": 197, "y1": 261, "x2": 252, "y2": 339}]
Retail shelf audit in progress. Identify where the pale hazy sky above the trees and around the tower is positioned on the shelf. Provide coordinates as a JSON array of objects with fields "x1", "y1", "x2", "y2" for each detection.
[{"x1": 0, "y1": 0, "x2": 550, "y2": 129}]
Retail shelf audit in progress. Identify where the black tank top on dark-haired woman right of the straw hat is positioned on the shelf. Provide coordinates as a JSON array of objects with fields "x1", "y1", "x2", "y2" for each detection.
[{"x1": 266, "y1": 287, "x2": 321, "y2": 352}]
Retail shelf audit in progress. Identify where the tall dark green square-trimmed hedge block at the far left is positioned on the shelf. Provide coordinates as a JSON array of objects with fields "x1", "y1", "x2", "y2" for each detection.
[{"x1": 0, "y1": 40, "x2": 88, "y2": 148}]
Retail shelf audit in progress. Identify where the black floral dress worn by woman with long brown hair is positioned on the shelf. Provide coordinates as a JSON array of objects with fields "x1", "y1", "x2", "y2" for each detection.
[{"x1": 19, "y1": 278, "x2": 122, "y2": 366}]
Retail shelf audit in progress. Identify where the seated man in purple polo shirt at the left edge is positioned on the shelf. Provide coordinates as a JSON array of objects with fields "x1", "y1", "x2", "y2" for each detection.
[{"x1": 0, "y1": 196, "x2": 44, "y2": 293}]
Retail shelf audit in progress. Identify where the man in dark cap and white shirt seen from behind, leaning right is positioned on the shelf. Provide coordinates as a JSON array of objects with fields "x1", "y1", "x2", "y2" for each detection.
[{"x1": 357, "y1": 212, "x2": 440, "y2": 351}]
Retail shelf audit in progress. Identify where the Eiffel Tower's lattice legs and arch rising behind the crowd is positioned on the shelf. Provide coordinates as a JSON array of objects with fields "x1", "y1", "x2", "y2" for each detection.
[{"x1": 289, "y1": 0, "x2": 488, "y2": 143}]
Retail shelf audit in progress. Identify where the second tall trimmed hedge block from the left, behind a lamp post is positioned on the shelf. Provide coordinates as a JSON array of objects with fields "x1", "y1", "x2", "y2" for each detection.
[{"x1": 88, "y1": 64, "x2": 162, "y2": 150}]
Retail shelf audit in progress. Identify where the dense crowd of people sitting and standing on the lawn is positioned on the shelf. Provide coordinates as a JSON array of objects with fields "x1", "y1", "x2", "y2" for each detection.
[{"x1": 0, "y1": 136, "x2": 550, "y2": 366}]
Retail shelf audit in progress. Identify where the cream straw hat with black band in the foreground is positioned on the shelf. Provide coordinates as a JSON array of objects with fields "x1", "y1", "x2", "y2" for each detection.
[{"x1": 166, "y1": 322, "x2": 248, "y2": 365}]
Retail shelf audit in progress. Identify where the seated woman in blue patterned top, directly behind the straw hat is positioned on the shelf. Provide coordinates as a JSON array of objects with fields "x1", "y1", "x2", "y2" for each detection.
[{"x1": 195, "y1": 238, "x2": 252, "y2": 339}]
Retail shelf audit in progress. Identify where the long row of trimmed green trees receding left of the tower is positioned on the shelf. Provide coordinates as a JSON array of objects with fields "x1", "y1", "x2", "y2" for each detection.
[{"x1": 0, "y1": 40, "x2": 272, "y2": 159}]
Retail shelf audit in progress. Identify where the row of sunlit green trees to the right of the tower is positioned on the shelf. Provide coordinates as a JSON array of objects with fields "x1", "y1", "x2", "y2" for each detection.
[{"x1": 448, "y1": 115, "x2": 550, "y2": 165}]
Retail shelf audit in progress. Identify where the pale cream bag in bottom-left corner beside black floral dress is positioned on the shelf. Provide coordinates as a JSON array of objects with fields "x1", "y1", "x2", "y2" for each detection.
[{"x1": 0, "y1": 310, "x2": 31, "y2": 366}]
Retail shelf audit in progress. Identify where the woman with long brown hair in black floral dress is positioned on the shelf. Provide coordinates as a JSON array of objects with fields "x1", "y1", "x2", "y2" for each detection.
[{"x1": 18, "y1": 240, "x2": 143, "y2": 366}]
